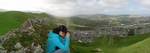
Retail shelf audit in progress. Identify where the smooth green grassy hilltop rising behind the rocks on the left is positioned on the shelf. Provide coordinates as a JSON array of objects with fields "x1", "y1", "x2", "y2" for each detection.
[{"x1": 0, "y1": 11, "x2": 48, "y2": 35}]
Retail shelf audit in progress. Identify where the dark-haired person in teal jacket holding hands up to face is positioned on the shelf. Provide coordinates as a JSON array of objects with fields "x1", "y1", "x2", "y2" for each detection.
[{"x1": 47, "y1": 25, "x2": 70, "y2": 53}]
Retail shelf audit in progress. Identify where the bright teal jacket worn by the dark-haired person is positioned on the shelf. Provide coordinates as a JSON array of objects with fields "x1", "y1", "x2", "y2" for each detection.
[{"x1": 47, "y1": 32, "x2": 70, "y2": 53}]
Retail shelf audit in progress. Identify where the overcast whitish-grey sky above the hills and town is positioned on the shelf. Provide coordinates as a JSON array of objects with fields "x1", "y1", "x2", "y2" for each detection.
[{"x1": 0, "y1": 0, "x2": 150, "y2": 16}]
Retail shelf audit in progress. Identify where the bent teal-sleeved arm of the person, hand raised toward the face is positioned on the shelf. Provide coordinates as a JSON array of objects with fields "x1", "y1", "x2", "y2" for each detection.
[{"x1": 52, "y1": 36, "x2": 70, "y2": 51}]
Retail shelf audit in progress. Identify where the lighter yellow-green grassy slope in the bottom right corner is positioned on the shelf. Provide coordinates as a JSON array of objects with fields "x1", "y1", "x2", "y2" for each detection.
[{"x1": 119, "y1": 38, "x2": 150, "y2": 53}]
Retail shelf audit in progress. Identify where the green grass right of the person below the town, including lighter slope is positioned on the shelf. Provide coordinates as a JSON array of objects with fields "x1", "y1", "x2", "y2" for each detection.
[{"x1": 71, "y1": 34, "x2": 150, "y2": 53}]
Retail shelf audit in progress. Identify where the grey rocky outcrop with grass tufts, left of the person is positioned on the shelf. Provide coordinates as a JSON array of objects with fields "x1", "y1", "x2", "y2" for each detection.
[{"x1": 0, "y1": 18, "x2": 50, "y2": 53}]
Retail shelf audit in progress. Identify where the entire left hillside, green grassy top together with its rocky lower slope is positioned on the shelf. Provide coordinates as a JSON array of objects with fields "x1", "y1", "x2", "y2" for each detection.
[{"x1": 0, "y1": 11, "x2": 55, "y2": 53}]
